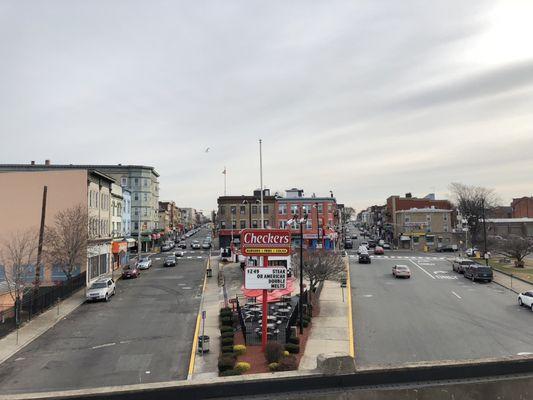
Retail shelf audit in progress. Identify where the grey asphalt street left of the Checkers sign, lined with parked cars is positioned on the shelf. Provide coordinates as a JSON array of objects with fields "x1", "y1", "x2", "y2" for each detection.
[{"x1": 0, "y1": 230, "x2": 209, "y2": 394}]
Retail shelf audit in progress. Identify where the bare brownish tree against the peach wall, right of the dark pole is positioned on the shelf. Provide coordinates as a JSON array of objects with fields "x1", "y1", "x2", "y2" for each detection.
[{"x1": 44, "y1": 204, "x2": 88, "y2": 279}]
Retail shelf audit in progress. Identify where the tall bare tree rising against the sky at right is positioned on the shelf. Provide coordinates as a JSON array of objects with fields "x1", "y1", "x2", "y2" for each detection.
[{"x1": 450, "y1": 182, "x2": 498, "y2": 243}]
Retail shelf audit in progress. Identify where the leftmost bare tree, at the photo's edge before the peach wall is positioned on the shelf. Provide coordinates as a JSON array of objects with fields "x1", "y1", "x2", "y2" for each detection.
[{"x1": 0, "y1": 230, "x2": 38, "y2": 315}]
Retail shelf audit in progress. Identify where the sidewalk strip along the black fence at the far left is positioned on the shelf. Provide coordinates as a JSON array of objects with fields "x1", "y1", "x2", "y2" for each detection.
[{"x1": 0, "y1": 288, "x2": 85, "y2": 364}]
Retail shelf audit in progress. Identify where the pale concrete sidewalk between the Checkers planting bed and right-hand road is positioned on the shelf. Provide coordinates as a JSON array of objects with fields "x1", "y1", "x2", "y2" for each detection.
[{"x1": 298, "y1": 281, "x2": 350, "y2": 370}]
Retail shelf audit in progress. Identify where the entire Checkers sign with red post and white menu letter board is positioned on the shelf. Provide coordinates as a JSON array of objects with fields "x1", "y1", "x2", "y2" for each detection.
[{"x1": 241, "y1": 230, "x2": 291, "y2": 351}]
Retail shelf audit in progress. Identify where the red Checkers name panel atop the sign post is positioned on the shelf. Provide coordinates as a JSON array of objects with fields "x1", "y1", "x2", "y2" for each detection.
[{"x1": 241, "y1": 229, "x2": 291, "y2": 256}]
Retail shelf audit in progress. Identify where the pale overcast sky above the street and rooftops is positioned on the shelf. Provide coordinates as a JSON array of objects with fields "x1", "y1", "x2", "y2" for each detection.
[{"x1": 0, "y1": 0, "x2": 533, "y2": 210}]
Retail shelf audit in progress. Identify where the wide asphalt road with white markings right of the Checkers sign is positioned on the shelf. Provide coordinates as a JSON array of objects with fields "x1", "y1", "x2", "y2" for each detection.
[{"x1": 350, "y1": 252, "x2": 533, "y2": 366}]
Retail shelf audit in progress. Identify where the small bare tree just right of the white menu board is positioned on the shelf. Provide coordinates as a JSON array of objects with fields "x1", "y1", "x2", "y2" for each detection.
[{"x1": 292, "y1": 249, "x2": 345, "y2": 292}]
